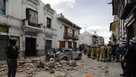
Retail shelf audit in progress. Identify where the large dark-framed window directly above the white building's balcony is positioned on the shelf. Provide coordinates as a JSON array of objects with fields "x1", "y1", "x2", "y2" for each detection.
[{"x1": 26, "y1": 8, "x2": 38, "y2": 27}]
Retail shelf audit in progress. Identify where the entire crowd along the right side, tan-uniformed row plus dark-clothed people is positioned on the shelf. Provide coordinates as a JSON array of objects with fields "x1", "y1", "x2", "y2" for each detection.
[{"x1": 85, "y1": 38, "x2": 136, "y2": 77}]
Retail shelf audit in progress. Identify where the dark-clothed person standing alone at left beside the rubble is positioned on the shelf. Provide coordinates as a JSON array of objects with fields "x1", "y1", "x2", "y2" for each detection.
[{"x1": 6, "y1": 39, "x2": 18, "y2": 77}]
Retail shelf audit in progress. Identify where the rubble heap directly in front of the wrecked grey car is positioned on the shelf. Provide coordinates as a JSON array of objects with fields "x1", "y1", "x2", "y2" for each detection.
[{"x1": 45, "y1": 59, "x2": 78, "y2": 73}]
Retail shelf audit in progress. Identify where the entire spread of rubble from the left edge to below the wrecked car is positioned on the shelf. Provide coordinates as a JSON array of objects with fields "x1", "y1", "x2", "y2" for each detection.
[{"x1": 0, "y1": 57, "x2": 78, "y2": 77}]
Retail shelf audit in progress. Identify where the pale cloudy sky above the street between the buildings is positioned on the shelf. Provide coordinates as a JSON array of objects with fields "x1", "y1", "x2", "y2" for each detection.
[{"x1": 42, "y1": 0, "x2": 112, "y2": 43}]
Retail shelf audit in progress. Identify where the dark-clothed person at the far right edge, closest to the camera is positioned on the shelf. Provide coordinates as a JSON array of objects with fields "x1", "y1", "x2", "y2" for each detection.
[{"x1": 125, "y1": 38, "x2": 136, "y2": 77}]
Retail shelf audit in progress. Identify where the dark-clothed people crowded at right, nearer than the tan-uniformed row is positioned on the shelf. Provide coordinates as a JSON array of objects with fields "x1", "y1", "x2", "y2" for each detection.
[{"x1": 111, "y1": 37, "x2": 136, "y2": 77}]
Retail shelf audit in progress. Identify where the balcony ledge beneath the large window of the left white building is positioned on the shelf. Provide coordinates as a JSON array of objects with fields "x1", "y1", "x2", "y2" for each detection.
[{"x1": 23, "y1": 19, "x2": 42, "y2": 32}]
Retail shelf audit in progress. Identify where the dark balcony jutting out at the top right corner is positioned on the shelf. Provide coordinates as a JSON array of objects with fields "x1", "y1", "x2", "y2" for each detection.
[{"x1": 121, "y1": 0, "x2": 136, "y2": 19}]
